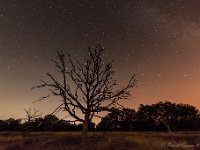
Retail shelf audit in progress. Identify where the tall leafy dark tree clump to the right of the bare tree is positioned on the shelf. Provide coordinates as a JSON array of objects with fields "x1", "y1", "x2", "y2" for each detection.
[{"x1": 97, "y1": 102, "x2": 200, "y2": 132}]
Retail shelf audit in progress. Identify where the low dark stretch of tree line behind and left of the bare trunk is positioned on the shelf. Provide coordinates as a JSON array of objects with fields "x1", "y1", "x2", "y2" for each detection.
[{"x1": 0, "y1": 114, "x2": 95, "y2": 132}]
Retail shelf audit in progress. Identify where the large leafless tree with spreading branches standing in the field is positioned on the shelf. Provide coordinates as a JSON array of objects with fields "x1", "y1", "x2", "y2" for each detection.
[{"x1": 34, "y1": 45, "x2": 136, "y2": 137}]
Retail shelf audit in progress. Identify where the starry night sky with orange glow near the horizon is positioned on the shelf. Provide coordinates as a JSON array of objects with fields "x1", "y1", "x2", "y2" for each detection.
[{"x1": 0, "y1": 0, "x2": 200, "y2": 119}]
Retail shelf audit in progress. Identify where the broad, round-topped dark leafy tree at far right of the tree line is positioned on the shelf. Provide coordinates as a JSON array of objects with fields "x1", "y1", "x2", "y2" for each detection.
[{"x1": 137, "y1": 101, "x2": 199, "y2": 132}]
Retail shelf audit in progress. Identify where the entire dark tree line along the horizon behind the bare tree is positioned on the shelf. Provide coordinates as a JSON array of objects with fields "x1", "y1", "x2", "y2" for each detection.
[{"x1": 0, "y1": 101, "x2": 200, "y2": 132}]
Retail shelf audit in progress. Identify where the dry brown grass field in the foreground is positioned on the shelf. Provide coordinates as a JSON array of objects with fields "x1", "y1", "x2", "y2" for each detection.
[{"x1": 0, "y1": 132, "x2": 200, "y2": 150}]
